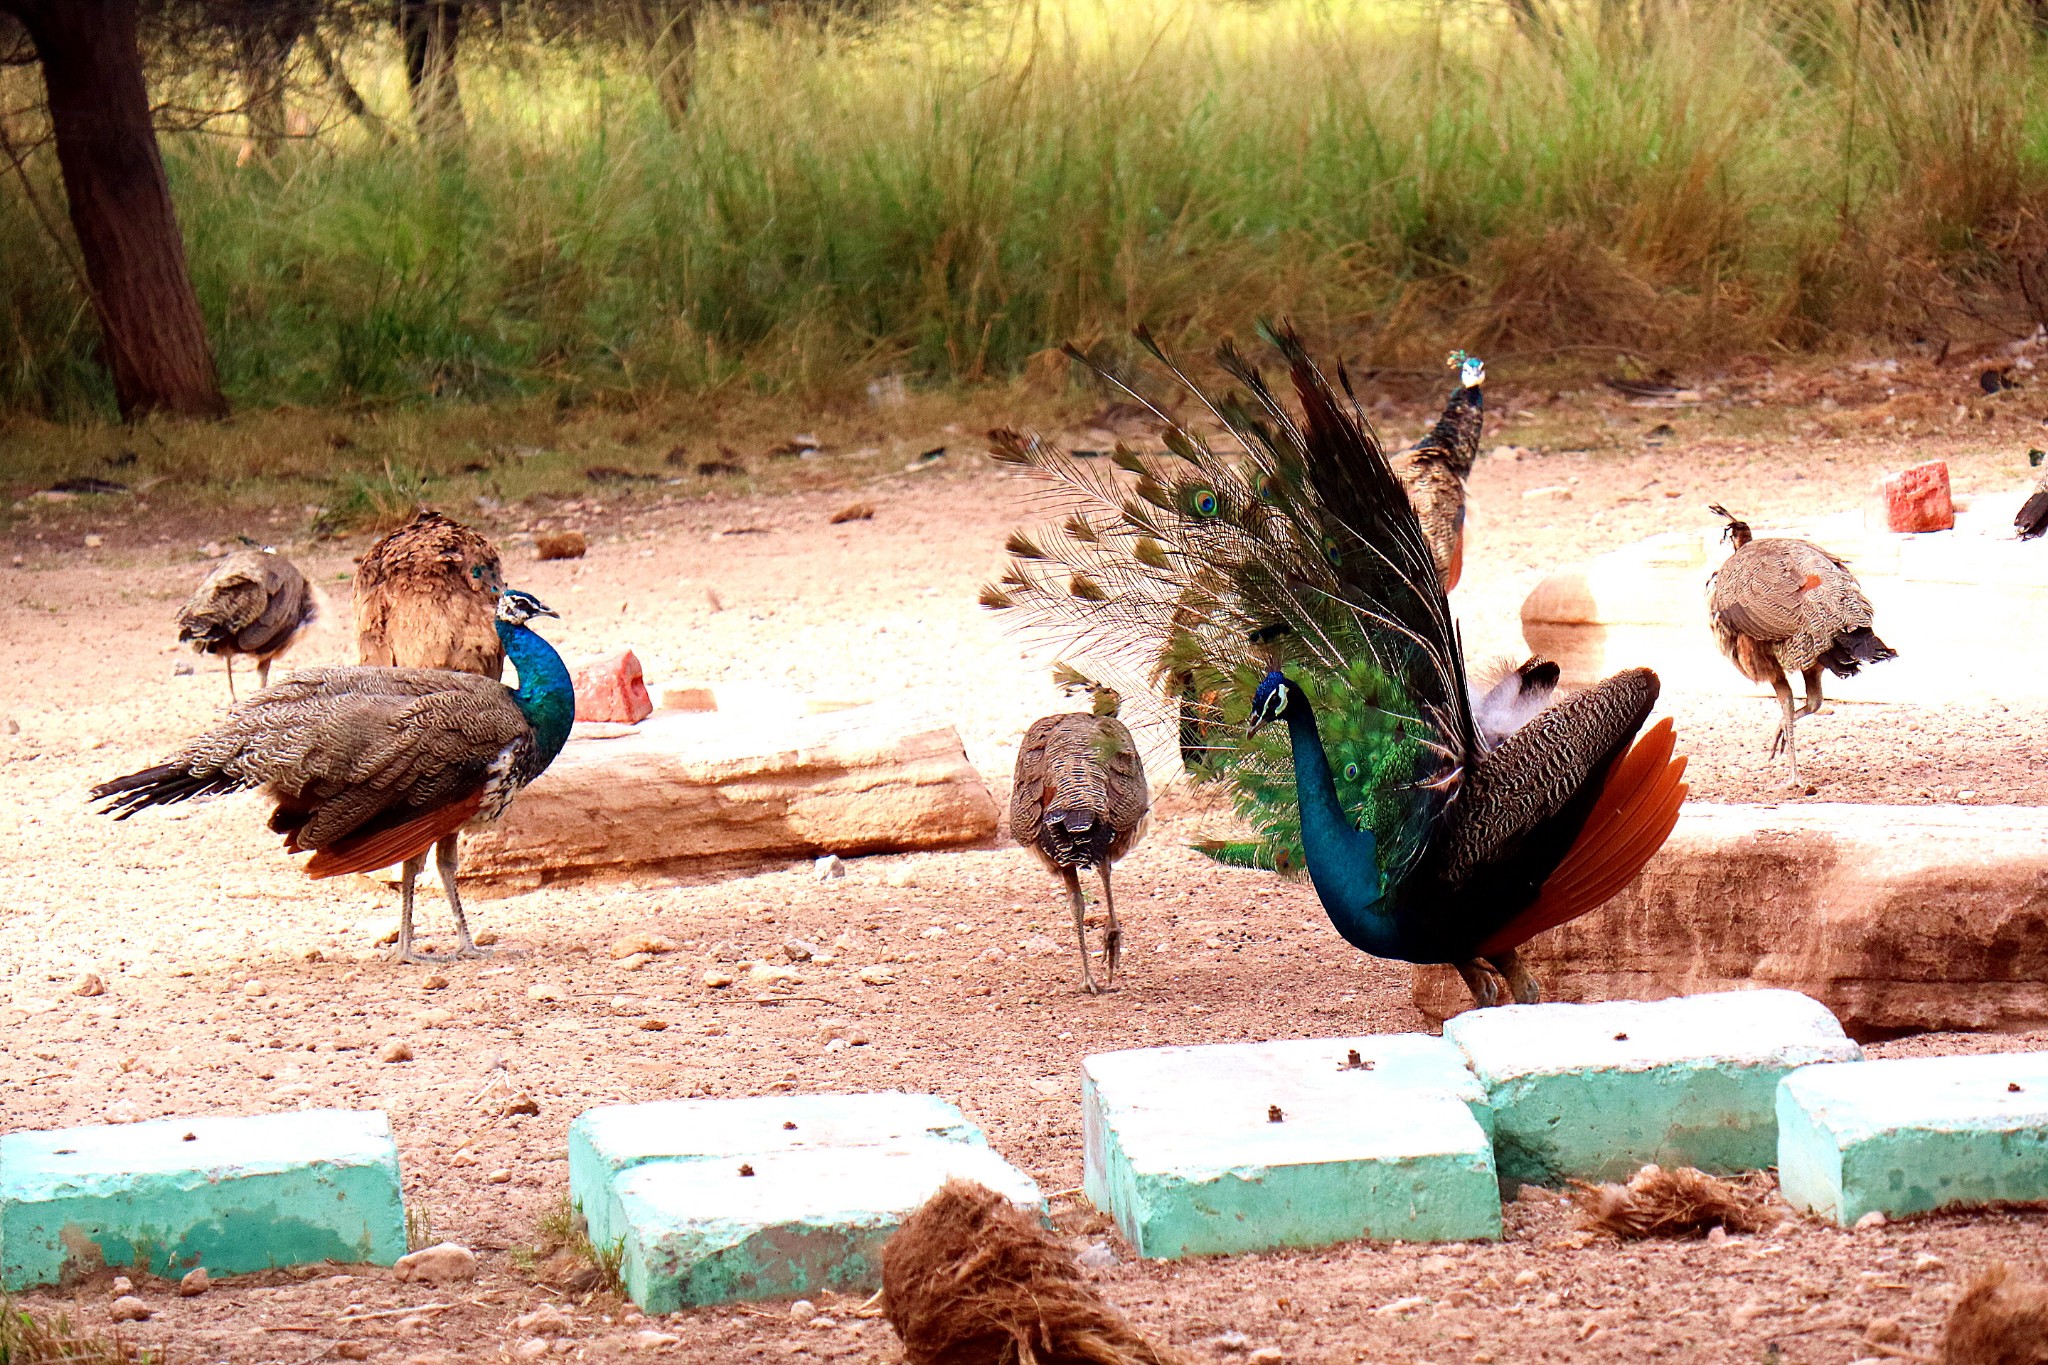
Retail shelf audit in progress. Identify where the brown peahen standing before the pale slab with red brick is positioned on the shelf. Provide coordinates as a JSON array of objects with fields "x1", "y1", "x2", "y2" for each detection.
[{"x1": 1706, "y1": 503, "x2": 1898, "y2": 786}]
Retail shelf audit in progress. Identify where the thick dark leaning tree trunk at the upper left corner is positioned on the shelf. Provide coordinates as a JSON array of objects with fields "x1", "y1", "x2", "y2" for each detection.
[{"x1": 0, "y1": 0, "x2": 227, "y2": 417}]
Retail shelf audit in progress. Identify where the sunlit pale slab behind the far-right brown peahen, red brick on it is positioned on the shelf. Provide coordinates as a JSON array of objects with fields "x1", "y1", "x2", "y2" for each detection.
[{"x1": 1522, "y1": 505, "x2": 2048, "y2": 699}]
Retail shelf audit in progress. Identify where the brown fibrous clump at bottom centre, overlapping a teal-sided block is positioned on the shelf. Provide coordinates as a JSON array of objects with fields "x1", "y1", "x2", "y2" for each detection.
[{"x1": 883, "y1": 1181, "x2": 1182, "y2": 1365}]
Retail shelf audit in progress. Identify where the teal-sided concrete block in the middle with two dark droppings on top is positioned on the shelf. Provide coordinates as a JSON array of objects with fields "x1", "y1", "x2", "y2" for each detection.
[{"x1": 1081, "y1": 1033, "x2": 1501, "y2": 1259}]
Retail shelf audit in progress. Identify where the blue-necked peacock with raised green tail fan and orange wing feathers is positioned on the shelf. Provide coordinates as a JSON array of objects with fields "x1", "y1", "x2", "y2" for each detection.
[{"x1": 981, "y1": 332, "x2": 1686, "y2": 1005}]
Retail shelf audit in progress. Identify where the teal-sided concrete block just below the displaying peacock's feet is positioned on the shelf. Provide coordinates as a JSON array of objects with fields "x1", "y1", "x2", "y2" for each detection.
[{"x1": 1444, "y1": 990, "x2": 1862, "y2": 1185}]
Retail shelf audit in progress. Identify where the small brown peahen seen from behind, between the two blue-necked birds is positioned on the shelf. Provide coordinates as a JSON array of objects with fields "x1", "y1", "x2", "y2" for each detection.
[{"x1": 1010, "y1": 669, "x2": 1151, "y2": 995}]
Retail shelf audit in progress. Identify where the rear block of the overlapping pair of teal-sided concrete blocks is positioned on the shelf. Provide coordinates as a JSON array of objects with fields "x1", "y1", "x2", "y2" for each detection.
[{"x1": 569, "y1": 1091, "x2": 985, "y2": 1246}]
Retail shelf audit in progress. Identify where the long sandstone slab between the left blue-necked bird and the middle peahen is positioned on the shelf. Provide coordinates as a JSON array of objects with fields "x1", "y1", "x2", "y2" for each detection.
[{"x1": 448, "y1": 706, "x2": 995, "y2": 882}]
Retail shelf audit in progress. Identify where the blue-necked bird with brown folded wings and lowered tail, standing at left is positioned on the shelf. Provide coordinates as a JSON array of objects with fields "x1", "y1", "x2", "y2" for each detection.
[{"x1": 92, "y1": 589, "x2": 575, "y2": 962}]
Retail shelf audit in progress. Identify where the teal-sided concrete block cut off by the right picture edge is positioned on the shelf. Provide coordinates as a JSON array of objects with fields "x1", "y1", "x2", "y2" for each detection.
[{"x1": 1778, "y1": 1052, "x2": 2048, "y2": 1226}]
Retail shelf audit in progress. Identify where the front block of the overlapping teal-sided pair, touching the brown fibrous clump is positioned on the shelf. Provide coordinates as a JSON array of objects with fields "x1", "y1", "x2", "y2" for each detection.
[{"x1": 616, "y1": 1138, "x2": 1044, "y2": 1314}]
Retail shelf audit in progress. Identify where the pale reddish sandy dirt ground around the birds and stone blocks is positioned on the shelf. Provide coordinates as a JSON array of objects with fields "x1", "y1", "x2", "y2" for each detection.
[{"x1": 0, "y1": 370, "x2": 2048, "y2": 1365}]
